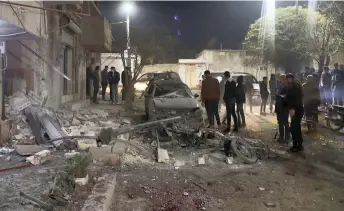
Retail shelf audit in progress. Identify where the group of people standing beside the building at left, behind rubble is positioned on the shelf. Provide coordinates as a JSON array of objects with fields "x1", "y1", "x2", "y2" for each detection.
[{"x1": 86, "y1": 66, "x2": 130, "y2": 104}]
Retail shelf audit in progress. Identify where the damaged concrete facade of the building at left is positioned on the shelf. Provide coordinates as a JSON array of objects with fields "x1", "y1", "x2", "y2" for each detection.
[{"x1": 0, "y1": 1, "x2": 93, "y2": 108}]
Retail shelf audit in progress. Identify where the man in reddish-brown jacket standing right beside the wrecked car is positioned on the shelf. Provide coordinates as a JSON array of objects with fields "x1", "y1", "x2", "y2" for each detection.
[{"x1": 201, "y1": 70, "x2": 221, "y2": 128}]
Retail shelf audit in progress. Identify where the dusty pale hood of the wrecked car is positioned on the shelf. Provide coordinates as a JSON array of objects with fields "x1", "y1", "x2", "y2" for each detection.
[{"x1": 153, "y1": 98, "x2": 200, "y2": 110}]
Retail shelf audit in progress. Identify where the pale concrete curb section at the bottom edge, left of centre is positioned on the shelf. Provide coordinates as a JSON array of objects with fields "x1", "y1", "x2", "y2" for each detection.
[{"x1": 81, "y1": 173, "x2": 117, "y2": 211}]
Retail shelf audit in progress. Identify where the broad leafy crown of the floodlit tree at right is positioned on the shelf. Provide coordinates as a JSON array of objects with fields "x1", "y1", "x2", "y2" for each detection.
[{"x1": 245, "y1": 6, "x2": 342, "y2": 72}]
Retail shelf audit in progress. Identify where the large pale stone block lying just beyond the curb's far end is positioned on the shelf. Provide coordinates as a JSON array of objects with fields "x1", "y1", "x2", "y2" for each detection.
[{"x1": 89, "y1": 146, "x2": 123, "y2": 166}]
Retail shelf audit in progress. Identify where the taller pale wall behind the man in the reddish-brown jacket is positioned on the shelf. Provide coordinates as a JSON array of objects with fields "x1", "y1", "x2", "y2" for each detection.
[{"x1": 196, "y1": 50, "x2": 275, "y2": 80}]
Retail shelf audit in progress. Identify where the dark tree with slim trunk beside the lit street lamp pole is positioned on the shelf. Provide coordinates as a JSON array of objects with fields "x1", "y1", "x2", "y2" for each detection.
[{"x1": 114, "y1": 25, "x2": 179, "y2": 109}]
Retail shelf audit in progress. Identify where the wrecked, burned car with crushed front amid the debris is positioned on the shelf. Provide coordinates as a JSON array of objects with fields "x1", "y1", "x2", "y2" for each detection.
[{"x1": 145, "y1": 80, "x2": 203, "y2": 141}]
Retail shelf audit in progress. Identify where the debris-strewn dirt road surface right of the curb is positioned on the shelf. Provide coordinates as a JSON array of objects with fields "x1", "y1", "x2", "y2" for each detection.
[{"x1": 112, "y1": 101, "x2": 344, "y2": 211}]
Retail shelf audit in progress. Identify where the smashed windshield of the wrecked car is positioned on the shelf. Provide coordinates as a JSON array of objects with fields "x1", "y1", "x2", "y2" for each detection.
[{"x1": 154, "y1": 85, "x2": 192, "y2": 98}]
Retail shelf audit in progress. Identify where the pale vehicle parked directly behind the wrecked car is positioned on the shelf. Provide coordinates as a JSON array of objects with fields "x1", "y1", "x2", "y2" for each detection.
[{"x1": 135, "y1": 71, "x2": 181, "y2": 92}]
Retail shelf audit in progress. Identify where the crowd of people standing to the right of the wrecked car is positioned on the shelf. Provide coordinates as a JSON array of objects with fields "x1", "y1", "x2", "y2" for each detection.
[{"x1": 201, "y1": 63, "x2": 344, "y2": 152}]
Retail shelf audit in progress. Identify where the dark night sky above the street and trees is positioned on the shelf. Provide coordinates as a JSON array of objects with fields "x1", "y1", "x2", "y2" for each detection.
[{"x1": 99, "y1": 1, "x2": 295, "y2": 50}]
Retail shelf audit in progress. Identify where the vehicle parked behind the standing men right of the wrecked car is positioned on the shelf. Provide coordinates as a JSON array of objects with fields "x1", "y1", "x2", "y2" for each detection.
[{"x1": 198, "y1": 72, "x2": 260, "y2": 98}]
